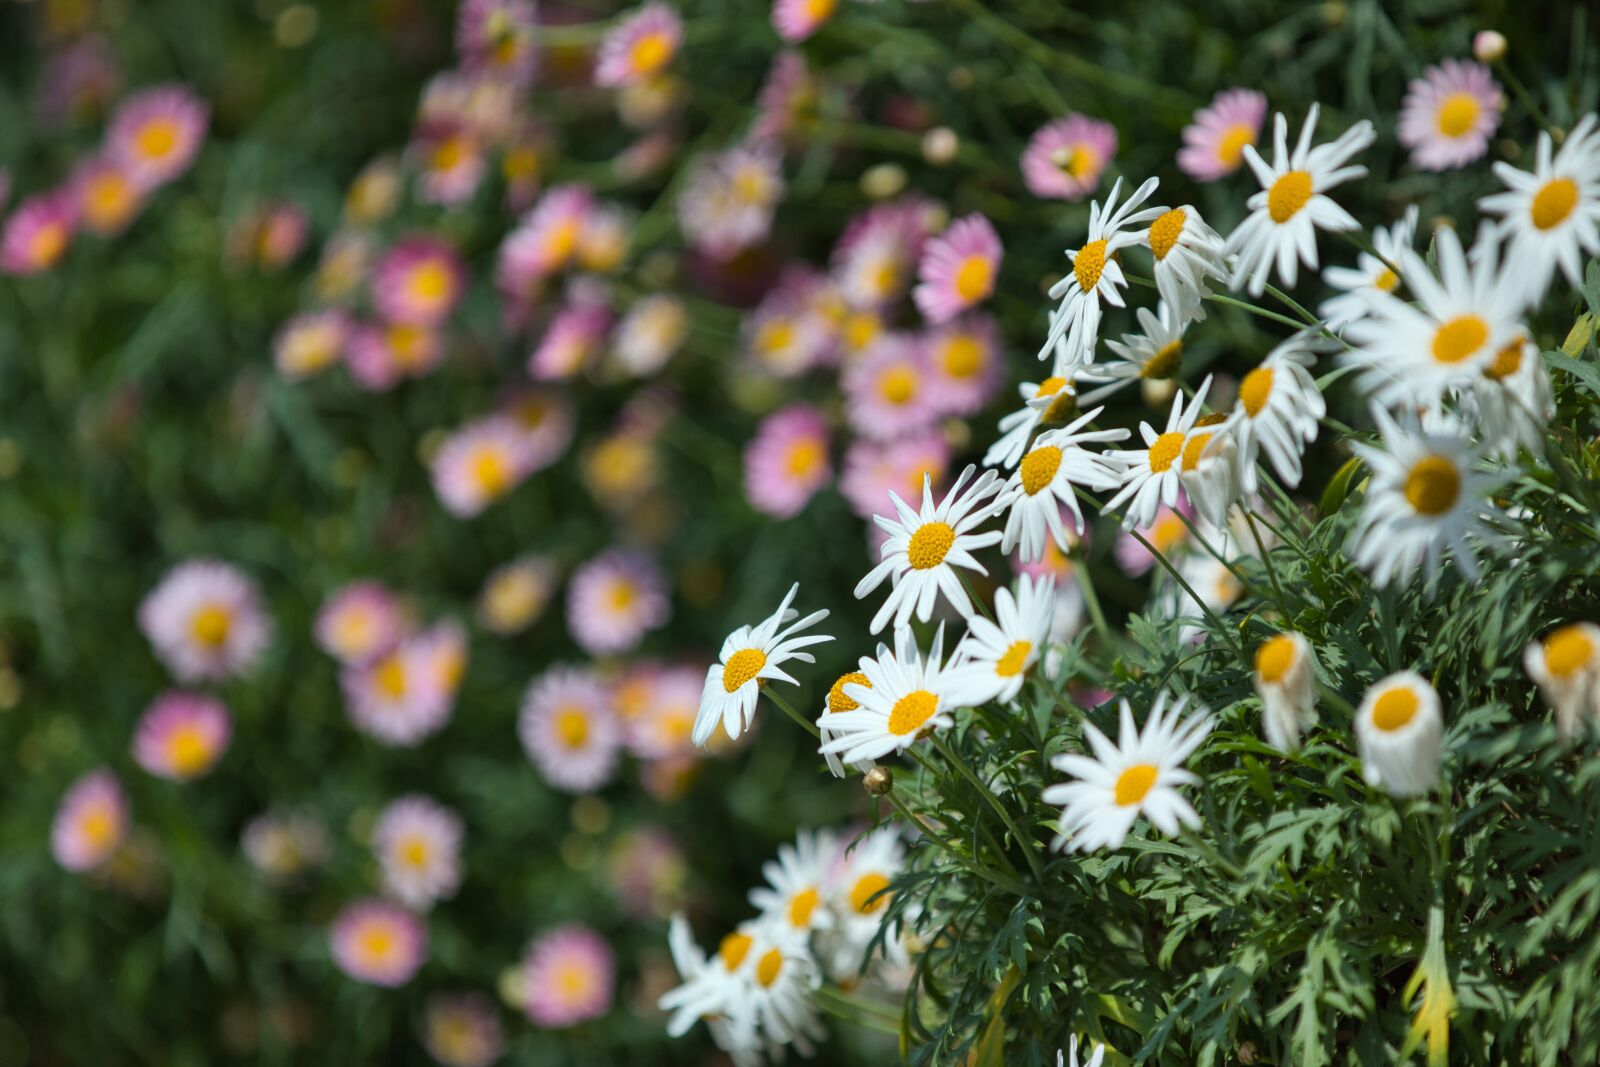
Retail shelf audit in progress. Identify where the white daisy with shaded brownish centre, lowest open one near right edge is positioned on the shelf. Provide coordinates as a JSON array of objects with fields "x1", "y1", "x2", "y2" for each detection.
[{"x1": 1349, "y1": 406, "x2": 1506, "y2": 587}]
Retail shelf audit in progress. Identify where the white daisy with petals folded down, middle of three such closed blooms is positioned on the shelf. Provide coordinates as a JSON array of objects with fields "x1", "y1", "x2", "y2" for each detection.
[{"x1": 1355, "y1": 670, "x2": 1445, "y2": 797}]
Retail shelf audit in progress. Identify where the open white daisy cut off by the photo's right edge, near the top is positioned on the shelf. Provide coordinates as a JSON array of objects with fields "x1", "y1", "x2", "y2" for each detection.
[{"x1": 1478, "y1": 114, "x2": 1600, "y2": 307}]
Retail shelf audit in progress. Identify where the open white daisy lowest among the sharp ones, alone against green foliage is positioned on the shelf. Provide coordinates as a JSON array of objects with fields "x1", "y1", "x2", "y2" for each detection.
[{"x1": 1043, "y1": 693, "x2": 1211, "y2": 851}]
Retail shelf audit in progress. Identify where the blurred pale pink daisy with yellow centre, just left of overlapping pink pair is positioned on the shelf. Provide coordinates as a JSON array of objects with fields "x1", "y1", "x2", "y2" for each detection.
[{"x1": 517, "y1": 667, "x2": 622, "y2": 793}]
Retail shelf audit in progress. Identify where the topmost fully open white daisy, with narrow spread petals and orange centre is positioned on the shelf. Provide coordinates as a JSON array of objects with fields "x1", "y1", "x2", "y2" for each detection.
[{"x1": 1222, "y1": 104, "x2": 1373, "y2": 296}]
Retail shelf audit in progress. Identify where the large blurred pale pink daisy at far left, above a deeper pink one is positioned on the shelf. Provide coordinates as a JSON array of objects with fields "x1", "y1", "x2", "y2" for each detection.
[{"x1": 139, "y1": 560, "x2": 272, "y2": 681}]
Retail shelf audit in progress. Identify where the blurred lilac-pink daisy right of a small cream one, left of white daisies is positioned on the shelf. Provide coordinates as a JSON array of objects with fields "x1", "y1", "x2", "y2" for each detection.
[{"x1": 566, "y1": 549, "x2": 672, "y2": 656}]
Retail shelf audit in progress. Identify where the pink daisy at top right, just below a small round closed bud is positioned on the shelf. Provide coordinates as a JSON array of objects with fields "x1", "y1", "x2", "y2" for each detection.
[{"x1": 1398, "y1": 59, "x2": 1506, "y2": 171}]
